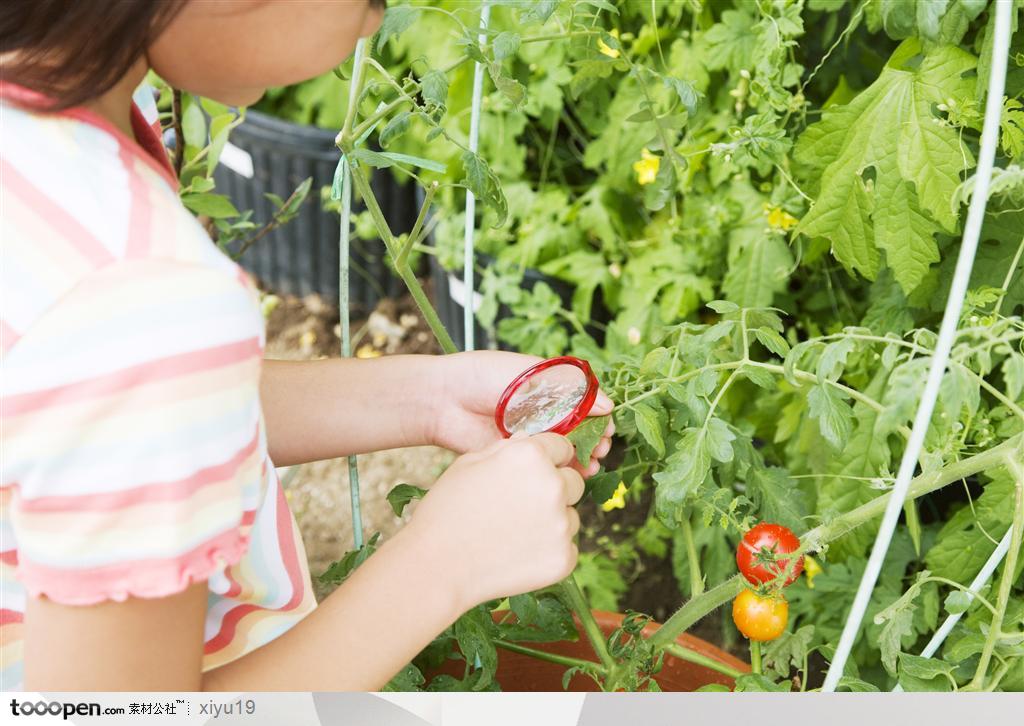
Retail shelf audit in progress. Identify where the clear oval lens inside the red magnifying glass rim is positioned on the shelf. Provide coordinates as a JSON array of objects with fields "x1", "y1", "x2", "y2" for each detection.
[{"x1": 504, "y1": 365, "x2": 588, "y2": 435}]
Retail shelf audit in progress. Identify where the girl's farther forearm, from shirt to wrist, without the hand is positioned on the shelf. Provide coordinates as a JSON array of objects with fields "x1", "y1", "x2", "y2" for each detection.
[{"x1": 260, "y1": 355, "x2": 442, "y2": 466}]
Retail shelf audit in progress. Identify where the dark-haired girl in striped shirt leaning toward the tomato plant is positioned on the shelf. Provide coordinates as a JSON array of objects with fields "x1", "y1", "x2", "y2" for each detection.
[{"x1": 0, "y1": 0, "x2": 611, "y2": 691}]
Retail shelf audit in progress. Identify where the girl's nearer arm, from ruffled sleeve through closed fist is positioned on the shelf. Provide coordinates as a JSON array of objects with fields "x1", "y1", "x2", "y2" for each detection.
[{"x1": 25, "y1": 434, "x2": 584, "y2": 691}]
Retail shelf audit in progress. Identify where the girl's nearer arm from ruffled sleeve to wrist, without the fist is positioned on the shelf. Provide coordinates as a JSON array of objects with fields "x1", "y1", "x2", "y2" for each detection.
[{"x1": 25, "y1": 533, "x2": 460, "y2": 691}]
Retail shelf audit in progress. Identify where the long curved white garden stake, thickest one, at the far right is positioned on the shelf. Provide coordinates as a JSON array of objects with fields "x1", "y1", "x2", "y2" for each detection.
[{"x1": 821, "y1": 0, "x2": 1013, "y2": 692}]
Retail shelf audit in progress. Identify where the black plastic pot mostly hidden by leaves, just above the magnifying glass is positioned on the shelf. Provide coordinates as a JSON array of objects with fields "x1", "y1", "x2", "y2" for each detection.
[{"x1": 427, "y1": 252, "x2": 611, "y2": 350}]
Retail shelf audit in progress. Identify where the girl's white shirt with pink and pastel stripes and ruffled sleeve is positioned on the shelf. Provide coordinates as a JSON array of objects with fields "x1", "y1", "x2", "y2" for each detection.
[{"x1": 0, "y1": 82, "x2": 315, "y2": 690}]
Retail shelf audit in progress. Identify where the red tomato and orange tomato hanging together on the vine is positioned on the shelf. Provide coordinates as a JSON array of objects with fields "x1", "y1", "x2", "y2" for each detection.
[{"x1": 732, "y1": 522, "x2": 804, "y2": 642}]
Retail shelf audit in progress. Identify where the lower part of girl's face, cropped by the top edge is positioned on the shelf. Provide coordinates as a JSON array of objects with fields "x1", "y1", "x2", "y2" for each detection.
[{"x1": 146, "y1": 0, "x2": 384, "y2": 105}]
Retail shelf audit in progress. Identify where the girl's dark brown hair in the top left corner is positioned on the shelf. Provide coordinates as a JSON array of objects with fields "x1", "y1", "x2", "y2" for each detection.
[{"x1": 0, "y1": 0, "x2": 187, "y2": 111}]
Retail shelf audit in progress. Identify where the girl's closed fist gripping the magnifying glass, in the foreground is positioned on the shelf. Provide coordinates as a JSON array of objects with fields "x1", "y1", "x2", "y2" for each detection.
[{"x1": 405, "y1": 433, "x2": 584, "y2": 612}]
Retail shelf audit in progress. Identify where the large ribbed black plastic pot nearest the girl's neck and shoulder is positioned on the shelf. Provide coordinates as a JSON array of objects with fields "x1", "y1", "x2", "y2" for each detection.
[{"x1": 214, "y1": 111, "x2": 418, "y2": 313}]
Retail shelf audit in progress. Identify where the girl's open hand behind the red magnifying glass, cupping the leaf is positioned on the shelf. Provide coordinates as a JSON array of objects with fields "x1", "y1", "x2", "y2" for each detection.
[{"x1": 430, "y1": 350, "x2": 615, "y2": 476}]
